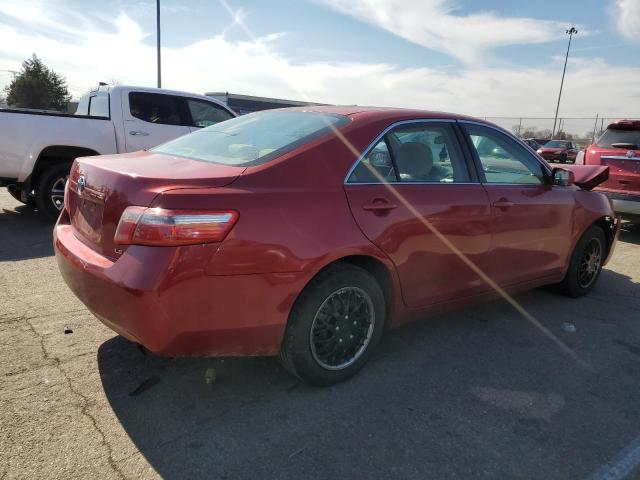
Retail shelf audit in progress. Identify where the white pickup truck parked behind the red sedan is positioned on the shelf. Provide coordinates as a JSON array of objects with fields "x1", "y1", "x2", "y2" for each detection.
[{"x1": 0, "y1": 84, "x2": 236, "y2": 217}]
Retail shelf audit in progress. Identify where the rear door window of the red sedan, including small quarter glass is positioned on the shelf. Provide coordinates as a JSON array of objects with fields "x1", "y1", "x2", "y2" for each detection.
[{"x1": 348, "y1": 122, "x2": 469, "y2": 183}]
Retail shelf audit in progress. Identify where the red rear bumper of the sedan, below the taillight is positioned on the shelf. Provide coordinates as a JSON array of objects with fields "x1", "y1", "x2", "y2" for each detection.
[{"x1": 53, "y1": 214, "x2": 308, "y2": 356}]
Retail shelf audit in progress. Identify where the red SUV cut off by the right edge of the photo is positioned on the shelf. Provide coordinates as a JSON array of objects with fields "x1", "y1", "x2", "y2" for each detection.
[{"x1": 576, "y1": 120, "x2": 640, "y2": 220}]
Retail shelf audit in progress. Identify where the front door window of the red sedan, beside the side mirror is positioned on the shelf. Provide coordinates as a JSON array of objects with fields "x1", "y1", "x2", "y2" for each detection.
[{"x1": 465, "y1": 124, "x2": 545, "y2": 184}]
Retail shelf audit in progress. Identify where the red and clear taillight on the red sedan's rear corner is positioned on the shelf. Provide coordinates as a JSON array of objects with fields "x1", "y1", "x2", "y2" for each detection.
[{"x1": 114, "y1": 207, "x2": 238, "y2": 246}]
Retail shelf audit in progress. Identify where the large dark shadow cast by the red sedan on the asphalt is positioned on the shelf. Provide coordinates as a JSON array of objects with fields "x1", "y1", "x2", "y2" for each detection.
[{"x1": 98, "y1": 270, "x2": 640, "y2": 479}]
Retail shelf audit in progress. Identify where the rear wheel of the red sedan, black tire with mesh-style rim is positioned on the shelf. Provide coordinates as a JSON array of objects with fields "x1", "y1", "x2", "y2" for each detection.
[{"x1": 280, "y1": 264, "x2": 386, "y2": 386}]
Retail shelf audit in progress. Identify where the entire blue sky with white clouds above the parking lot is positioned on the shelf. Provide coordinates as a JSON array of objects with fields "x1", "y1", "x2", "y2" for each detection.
[{"x1": 0, "y1": 0, "x2": 640, "y2": 124}]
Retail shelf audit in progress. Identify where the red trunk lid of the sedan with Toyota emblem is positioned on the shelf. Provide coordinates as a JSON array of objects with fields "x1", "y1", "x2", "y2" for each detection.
[{"x1": 66, "y1": 152, "x2": 245, "y2": 259}]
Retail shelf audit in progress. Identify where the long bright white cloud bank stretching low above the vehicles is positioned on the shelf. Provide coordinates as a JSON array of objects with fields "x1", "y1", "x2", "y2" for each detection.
[{"x1": 0, "y1": 2, "x2": 640, "y2": 127}]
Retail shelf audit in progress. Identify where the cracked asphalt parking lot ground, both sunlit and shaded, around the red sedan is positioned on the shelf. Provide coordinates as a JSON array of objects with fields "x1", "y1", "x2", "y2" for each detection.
[{"x1": 0, "y1": 189, "x2": 640, "y2": 479}]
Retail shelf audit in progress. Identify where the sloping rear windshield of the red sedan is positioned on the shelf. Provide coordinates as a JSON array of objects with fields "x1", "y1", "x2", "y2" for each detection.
[{"x1": 152, "y1": 110, "x2": 348, "y2": 166}]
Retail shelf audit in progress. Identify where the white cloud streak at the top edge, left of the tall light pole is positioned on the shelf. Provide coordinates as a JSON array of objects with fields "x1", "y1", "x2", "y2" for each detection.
[{"x1": 316, "y1": 0, "x2": 568, "y2": 64}]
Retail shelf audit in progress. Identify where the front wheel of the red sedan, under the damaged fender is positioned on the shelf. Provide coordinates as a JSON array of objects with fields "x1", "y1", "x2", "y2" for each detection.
[{"x1": 559, "y1": 225, "x2": 607, "y2": 298}]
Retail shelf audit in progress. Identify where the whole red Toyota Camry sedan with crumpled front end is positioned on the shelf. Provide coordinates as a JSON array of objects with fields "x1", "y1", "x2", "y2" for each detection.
[{"x1": 54, "y1": 107, "x2": 618, "y2": 385}]
